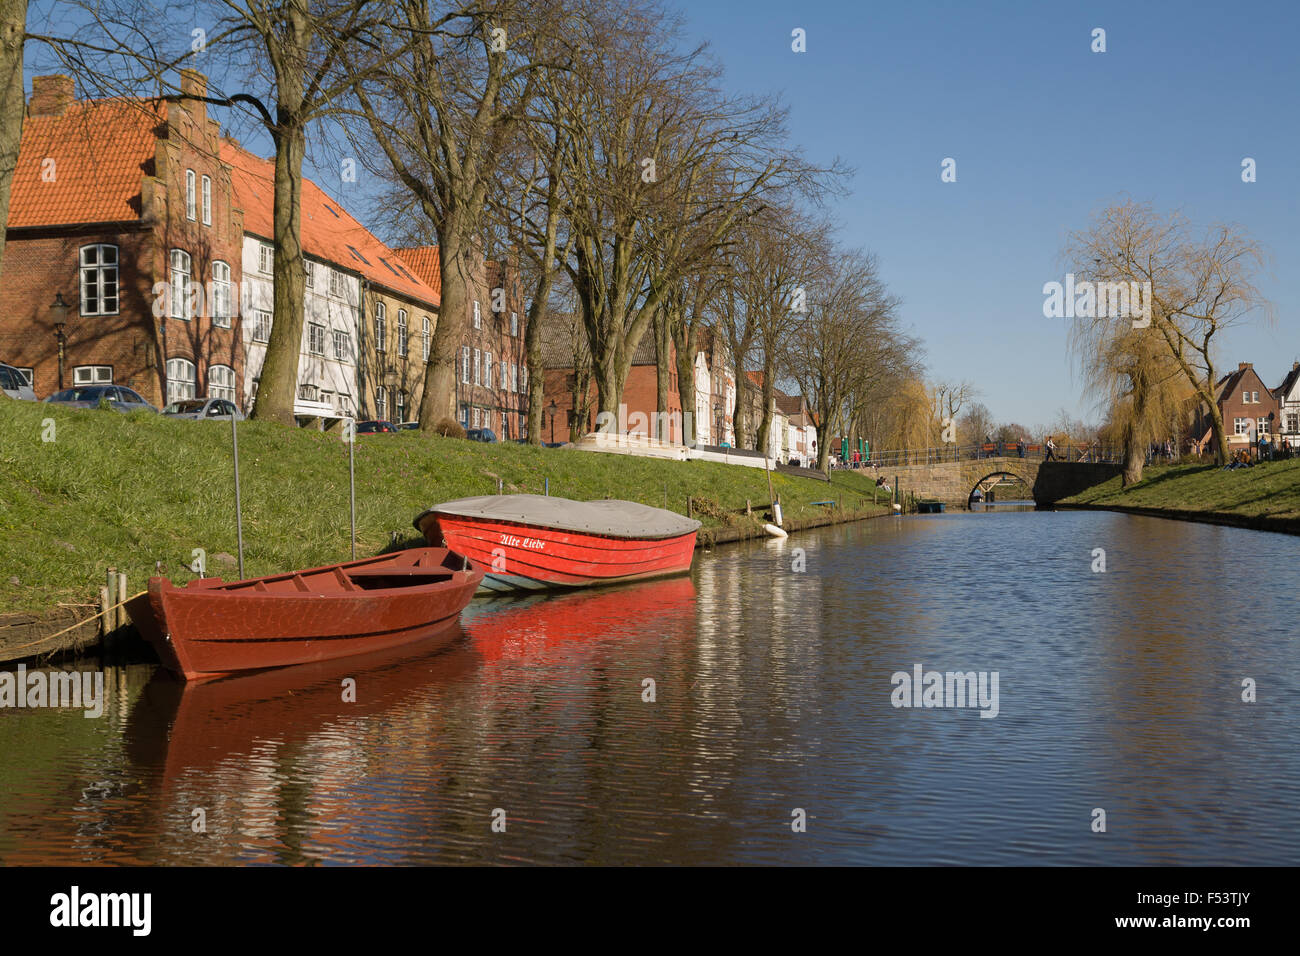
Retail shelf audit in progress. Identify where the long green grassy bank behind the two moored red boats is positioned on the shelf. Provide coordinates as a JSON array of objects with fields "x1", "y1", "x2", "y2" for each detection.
[{"x1": 0, "y1": 397, "x2": 884, "y2": 611}]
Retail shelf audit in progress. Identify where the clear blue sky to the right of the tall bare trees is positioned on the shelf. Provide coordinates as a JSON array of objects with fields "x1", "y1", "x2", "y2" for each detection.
[{"x1": 685, "y1": 0, "x2": 1300, "y2": 427}]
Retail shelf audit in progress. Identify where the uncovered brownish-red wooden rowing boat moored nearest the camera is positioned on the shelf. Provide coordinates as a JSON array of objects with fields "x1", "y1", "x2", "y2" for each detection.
[{"x1": 126, "y1": 548, "x2": 484, "y2": 680}]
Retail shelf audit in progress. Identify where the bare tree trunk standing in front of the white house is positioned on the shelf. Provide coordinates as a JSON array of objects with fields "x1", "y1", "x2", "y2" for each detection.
[{"x1": 250, "y1": 115, "x2": 306, "y2": 425}]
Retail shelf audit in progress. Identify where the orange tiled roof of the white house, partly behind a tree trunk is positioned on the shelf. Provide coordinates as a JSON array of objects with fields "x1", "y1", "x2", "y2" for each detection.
[{"x1": 221, "y1": 139, "x2": 442, "y2": 307}]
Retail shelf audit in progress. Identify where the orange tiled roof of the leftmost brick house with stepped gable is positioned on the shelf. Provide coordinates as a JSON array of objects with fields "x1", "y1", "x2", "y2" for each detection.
[{"x1": 8, "y1": 100, "x2": 166, "y2": 229}]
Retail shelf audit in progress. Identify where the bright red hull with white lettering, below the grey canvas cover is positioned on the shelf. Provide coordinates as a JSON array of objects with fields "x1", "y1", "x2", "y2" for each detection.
[{"x1": 417, "y1": 512, "x2": 696, "y2": 593}]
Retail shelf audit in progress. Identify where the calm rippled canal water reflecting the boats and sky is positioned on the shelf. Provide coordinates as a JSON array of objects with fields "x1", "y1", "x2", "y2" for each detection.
[{"x1": 0, "y1": 511, "x2": 1300, "y2": 865}]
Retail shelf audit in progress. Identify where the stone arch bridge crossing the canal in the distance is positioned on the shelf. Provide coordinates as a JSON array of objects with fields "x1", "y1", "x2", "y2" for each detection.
[{"x1": 880, "y1": 457, "x2": 1122, "y2": 505}]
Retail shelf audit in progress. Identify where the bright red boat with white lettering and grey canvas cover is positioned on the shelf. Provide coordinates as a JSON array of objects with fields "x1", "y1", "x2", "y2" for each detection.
[{"x1": 415, "y1": 494, "x2": 699, "y2": 592}]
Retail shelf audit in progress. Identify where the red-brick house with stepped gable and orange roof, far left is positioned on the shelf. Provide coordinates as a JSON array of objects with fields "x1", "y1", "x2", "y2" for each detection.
[{"x1": 0, "y1": 70, "x2": 244, "y2": 406}]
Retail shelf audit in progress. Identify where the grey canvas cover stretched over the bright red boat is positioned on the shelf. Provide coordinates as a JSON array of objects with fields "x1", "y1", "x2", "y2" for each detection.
[{"x1": 415, "y1": 494, "x2": 699, "y2": 538}]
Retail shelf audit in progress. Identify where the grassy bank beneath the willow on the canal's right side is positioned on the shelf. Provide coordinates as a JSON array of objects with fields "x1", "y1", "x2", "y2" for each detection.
[{"x1": 1060, "y1": 459, "x2": 1300, "y2": 533}]
